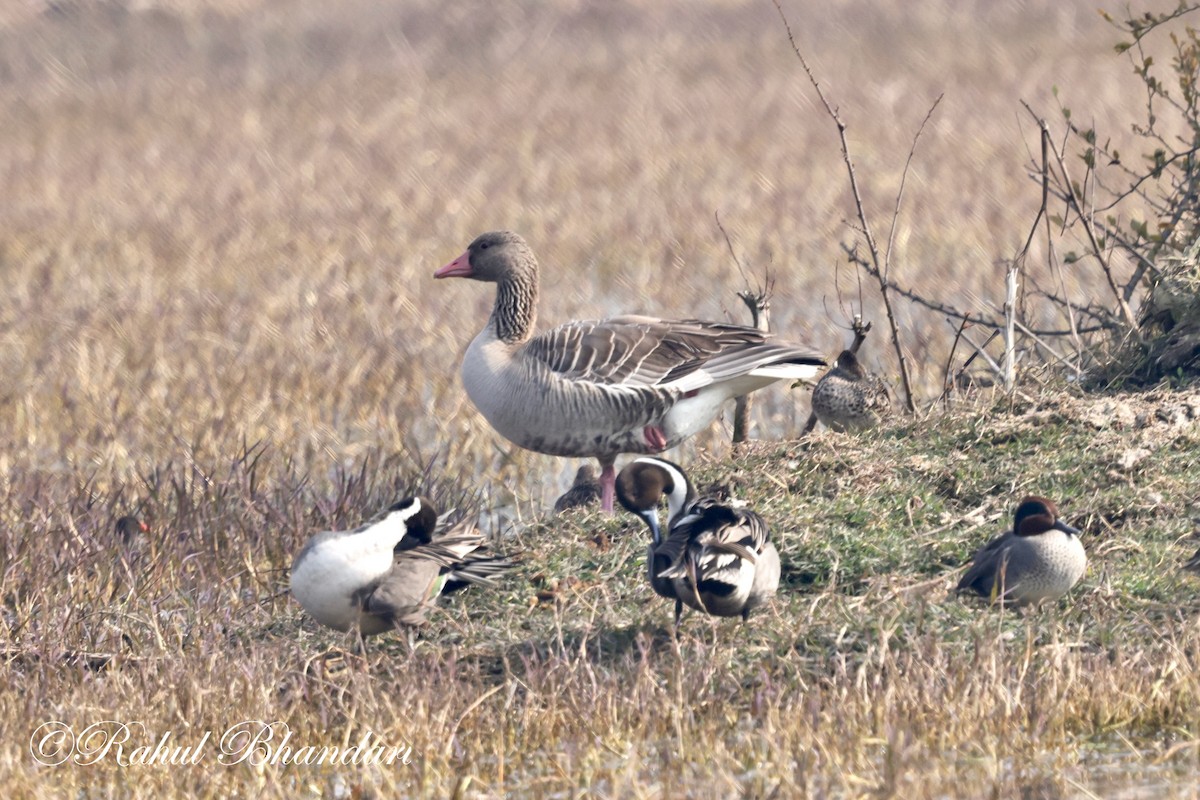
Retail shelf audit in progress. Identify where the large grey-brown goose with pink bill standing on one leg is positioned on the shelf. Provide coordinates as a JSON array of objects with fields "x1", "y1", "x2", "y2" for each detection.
[{"x1": 433, "y1": 230, "x2": 826, "y2": 513}]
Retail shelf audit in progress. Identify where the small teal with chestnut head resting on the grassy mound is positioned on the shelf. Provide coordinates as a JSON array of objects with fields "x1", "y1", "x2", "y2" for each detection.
[{"x1": 958, "y1": 495, "x2": 1087, "y2": 607}]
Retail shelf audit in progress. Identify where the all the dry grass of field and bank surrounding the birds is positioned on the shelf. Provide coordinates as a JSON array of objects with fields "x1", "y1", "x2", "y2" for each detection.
[{"x1": 0, "y1": 0, "x2": 1200, "y2": 798}]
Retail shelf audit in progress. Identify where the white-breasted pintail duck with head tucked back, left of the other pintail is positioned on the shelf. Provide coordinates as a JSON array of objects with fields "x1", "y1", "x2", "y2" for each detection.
[{"x1": 292, "y1": 495, "x2": 514, "y2": 636}]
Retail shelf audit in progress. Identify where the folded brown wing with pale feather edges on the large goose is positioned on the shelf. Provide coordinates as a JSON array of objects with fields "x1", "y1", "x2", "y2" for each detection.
[{"x1": 524, "y1": 315, "x2": 822, "y2": 391}]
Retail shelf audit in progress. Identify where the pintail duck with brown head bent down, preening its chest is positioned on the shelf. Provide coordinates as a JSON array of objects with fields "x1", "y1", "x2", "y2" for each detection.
[{"x1": 616, "y1": 456, "x2": 780, "y2": 628}]
